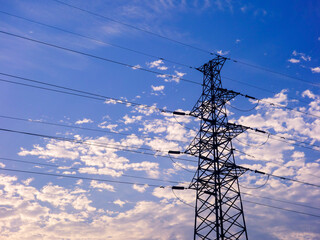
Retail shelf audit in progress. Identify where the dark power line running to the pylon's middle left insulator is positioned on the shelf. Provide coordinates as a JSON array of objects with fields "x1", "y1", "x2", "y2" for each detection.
[{"x1": 0, "y1": 128, "x2": 196, "y2": 162}]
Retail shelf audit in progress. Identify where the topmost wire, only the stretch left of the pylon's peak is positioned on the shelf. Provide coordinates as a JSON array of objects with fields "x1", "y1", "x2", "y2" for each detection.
[{"x1": 53, "y1": 0, "x2": 214, "y2": 55}]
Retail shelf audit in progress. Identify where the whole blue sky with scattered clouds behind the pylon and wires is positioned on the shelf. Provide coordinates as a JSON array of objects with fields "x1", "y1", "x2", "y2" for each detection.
[{"x1": 0, "y1": 0, "x2": 320, "y2": 240}]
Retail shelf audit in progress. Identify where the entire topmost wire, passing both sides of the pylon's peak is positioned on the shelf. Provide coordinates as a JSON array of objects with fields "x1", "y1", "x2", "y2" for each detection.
[{"x1": 52, "y1": 0, "x2": 320, "y2": 87}]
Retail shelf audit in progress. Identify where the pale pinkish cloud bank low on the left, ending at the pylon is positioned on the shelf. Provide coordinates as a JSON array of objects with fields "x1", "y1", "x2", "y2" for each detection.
[{"x1": 0, "y1": 175, "x2": 193, "y2": 240}]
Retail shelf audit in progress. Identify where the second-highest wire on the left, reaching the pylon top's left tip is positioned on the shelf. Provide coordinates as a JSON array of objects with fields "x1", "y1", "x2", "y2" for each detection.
[{"x1": 0, "y1": 10, "x2": 195, "y2": 69}]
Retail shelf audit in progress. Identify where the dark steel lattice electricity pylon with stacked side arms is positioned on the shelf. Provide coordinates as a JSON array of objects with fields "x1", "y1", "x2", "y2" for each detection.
[{"x1": 185, "y1": 56, "x2": 248, "y2": 240}]
